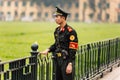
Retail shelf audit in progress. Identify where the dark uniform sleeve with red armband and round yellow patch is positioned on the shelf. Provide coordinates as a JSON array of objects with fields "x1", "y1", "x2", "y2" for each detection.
[{"x1": 69, "y1": 30, "x2": 78, "y2": 62}]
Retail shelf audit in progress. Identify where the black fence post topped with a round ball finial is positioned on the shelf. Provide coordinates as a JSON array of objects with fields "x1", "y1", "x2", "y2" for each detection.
[{"x1": 30, "y1": 43, "x2": 39, "y2": 80}]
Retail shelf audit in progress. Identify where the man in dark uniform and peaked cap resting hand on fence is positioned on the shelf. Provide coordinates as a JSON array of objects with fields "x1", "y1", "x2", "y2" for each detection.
[{"x1": 41, "y1": 7, "x2": 78, "y2": 80}]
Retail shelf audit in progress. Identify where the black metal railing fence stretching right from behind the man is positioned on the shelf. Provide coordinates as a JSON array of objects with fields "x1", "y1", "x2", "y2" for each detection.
[{"x1": 75, "y1": 38, "x2": 120, "y2": 80}]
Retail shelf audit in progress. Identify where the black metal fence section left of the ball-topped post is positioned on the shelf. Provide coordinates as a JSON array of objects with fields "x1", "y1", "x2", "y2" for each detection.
[{"x1": 0, "y1": 56, "x2": 37, "y2": 80}]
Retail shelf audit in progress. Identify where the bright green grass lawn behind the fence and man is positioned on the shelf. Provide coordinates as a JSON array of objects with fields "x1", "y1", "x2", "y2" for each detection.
[{"x1": 0, "y1": 22, "x2": 120, "y2": 61}]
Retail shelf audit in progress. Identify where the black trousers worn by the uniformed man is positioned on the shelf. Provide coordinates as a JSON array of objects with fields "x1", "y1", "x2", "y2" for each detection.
[{"x1": 53, "y1": 58, "x2": 75, "y2": 80}]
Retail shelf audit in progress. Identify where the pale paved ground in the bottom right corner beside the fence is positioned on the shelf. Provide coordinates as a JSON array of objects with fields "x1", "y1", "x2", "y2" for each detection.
[{"x1": 99, "y1": 67, "x2": 120, "y2": 80}]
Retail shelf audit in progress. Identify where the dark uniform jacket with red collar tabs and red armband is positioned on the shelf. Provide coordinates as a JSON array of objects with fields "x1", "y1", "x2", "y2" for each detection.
[{"x1": 49, "y1": 24, "x2": 78, "y2": 61}]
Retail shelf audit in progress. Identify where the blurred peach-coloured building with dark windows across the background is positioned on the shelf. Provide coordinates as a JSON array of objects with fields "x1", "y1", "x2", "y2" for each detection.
[{"x1": 0, "y1": 0, "x2": 120, "y2": 22}]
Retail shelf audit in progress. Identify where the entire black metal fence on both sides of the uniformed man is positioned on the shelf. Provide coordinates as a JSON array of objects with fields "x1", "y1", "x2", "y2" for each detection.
[{"x1": 0, "y1": 38, "x2": 120, "y2": 80}]
